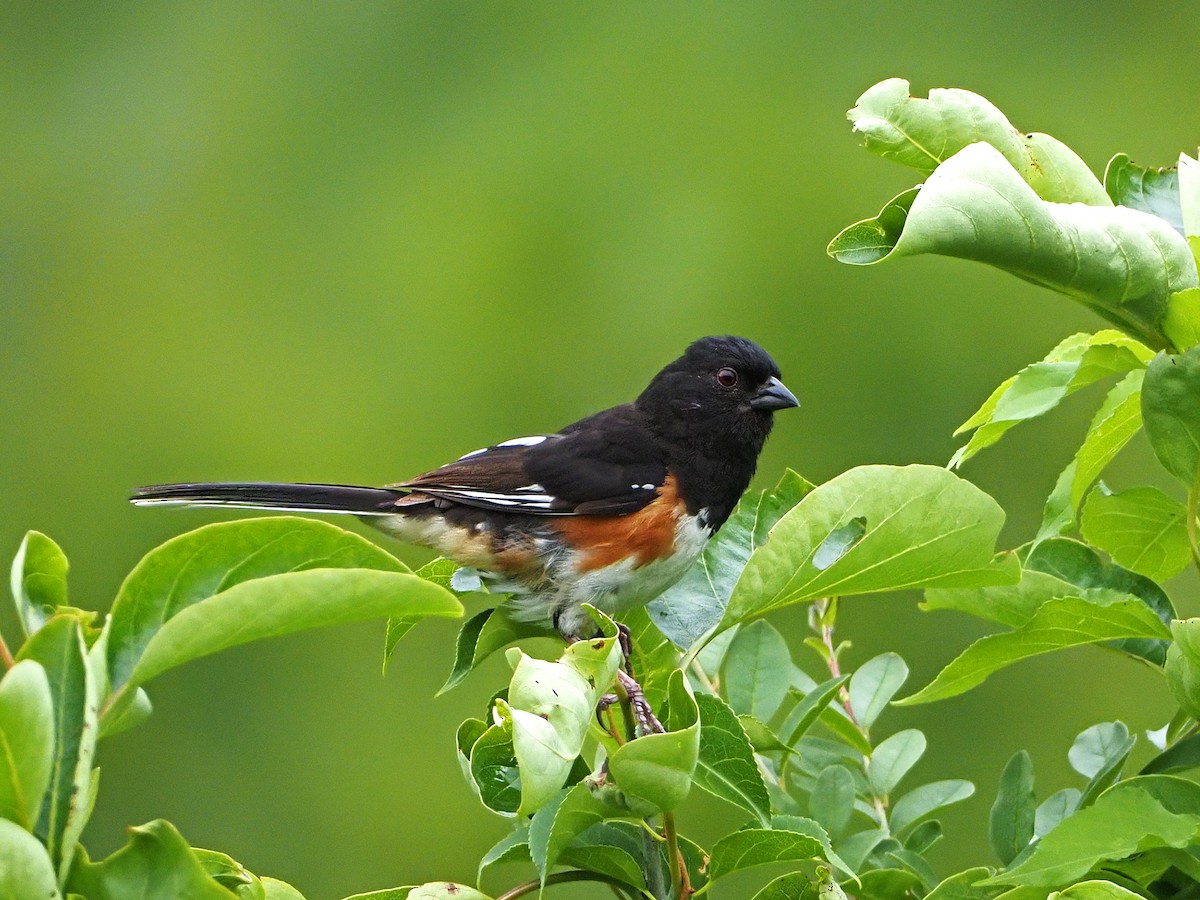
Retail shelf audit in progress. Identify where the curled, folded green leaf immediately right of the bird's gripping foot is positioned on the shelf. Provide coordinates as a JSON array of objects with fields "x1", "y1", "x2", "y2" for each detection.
[{"x1": 608, "y1": 670, "x2": 700, "y2": 817}]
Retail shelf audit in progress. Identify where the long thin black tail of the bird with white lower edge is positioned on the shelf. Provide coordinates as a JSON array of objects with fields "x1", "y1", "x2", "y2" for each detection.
[{"x1": 130, "y1": 481, "x2": 407, "y2": 516}]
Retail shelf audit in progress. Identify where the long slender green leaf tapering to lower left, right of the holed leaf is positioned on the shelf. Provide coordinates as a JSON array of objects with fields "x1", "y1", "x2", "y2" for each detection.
[{"x1": 898, "y1": 596, "x2": 1168, "y2": 706}]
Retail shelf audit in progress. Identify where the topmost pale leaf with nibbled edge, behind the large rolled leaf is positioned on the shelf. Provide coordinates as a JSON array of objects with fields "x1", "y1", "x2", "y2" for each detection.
[{"x1": 848, "y1": 78, "x2": 1112, "y2": 206}]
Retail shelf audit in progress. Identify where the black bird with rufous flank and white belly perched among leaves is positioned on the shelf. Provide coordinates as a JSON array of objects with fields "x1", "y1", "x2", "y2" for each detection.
[{"x1": 131, "y1": 336, "x2": 799, "y2": 641}]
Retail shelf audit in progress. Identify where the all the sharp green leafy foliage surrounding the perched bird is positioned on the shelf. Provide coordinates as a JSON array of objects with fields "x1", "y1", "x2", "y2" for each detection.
[{"x1": 0, "y1": 79, "x2": 1200, "y2": 900}]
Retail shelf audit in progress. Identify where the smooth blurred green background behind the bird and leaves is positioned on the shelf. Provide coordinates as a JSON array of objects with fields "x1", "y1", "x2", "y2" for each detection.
[{"x1": 0, "y1": 1, "x2": 1200, "y2": 898}]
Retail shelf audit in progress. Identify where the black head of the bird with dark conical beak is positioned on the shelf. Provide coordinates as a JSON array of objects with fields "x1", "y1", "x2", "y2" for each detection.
[{"x1": 637, "y1": 336, "x2": 798, "y2": 465}]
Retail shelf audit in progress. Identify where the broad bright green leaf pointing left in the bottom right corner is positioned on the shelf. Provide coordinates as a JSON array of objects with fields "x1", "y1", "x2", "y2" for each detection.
[{"x1": 984, "y1": 788, "x2": 1200, "y2": 887}]
